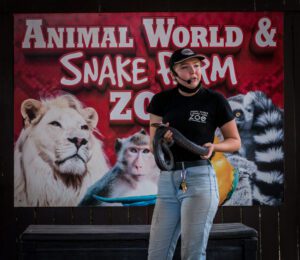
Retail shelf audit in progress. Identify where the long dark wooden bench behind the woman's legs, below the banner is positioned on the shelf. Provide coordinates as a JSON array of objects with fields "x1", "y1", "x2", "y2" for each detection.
[{"x1": 18, "y1": 223, "x2": 257, "y2": 260}]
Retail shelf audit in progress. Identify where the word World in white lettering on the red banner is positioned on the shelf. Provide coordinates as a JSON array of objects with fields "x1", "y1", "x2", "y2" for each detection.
[{"x1": 143, "y1": 18, "x2": 243, "y2": 50}]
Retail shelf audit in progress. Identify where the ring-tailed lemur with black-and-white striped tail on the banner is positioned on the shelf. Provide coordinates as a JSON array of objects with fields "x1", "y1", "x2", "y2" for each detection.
[{"x1": 228, "y1": 91, "x2": 284, "y2": 205}]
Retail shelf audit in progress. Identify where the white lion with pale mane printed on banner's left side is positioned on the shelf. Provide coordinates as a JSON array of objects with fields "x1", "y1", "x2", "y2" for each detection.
[{"x1": 14, "y1": 95, "x2": 109, "y2": 207}]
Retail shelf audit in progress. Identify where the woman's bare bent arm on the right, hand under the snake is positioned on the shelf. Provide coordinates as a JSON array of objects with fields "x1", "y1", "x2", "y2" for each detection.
[{"x1": 201, "y1": 119, "x2": 241, "y2": 159}]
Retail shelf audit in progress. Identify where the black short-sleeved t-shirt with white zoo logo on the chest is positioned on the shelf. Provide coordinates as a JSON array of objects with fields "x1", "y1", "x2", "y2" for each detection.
[{"x1": 147, "y1": 87, "x2": 234, "y2": 162}]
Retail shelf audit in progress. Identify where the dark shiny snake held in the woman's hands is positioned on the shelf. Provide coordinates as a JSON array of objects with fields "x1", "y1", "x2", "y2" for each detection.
[{"x1": 151, "y1": 123, "x2": 209, "y2": 171}]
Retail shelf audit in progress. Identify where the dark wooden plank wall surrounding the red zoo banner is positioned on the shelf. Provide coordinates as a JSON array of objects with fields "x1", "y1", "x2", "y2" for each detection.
[{"x1": 0, "y1": 0, "x2": 300, "y2": 260}]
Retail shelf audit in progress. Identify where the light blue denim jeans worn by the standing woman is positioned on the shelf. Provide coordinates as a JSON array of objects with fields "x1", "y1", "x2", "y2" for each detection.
[{"x1": 148, "y1": 165, "x2": 219, "y2": 260}]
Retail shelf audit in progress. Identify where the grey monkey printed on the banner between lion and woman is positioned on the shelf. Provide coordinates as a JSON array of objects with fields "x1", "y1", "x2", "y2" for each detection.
[{"x1": 78, "y1": 129, "x2": 160, "y2": 206}]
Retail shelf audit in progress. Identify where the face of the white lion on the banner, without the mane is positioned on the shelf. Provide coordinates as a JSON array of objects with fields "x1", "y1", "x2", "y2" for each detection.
[{"x1": 20, "y1": 95, "x2": 98, "y2": 176}]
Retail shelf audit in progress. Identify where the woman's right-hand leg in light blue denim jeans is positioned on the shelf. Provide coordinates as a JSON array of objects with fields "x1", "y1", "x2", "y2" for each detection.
[{"x1": 181, "y1": 166, "x2": 219, "y2": 260}]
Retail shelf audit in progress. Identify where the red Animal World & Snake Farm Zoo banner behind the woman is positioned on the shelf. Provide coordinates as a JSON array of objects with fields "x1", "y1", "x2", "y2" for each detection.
[{"x1": 14, "y1": 12, "x2": 284, "y2": 207}]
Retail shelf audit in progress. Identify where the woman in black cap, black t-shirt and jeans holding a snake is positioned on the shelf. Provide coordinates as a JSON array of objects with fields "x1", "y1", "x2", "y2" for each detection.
[{"x1": 147, "y1": 48, "x2": 241, "y2": 260}]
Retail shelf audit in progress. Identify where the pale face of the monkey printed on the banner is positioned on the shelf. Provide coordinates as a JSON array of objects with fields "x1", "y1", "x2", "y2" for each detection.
[{"x1": 124, "y1": 144, "x2": 155, "y2": 177}]
